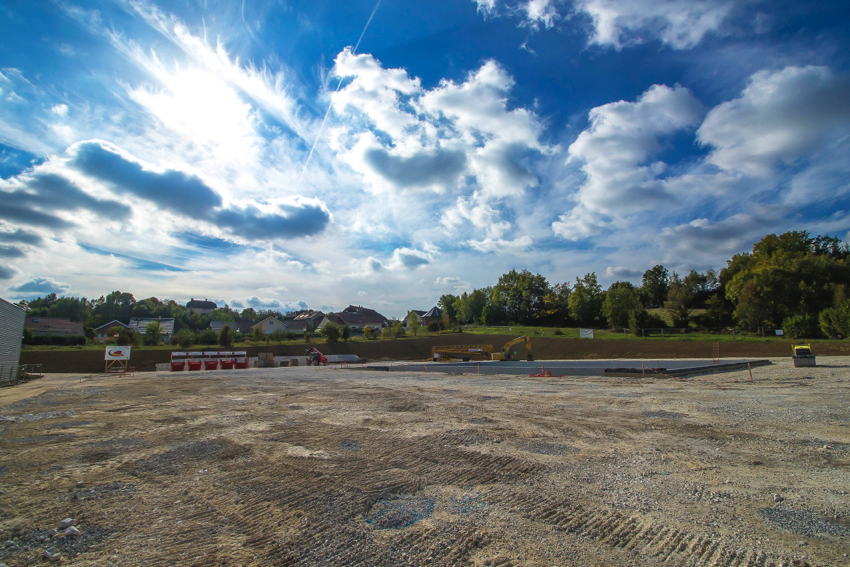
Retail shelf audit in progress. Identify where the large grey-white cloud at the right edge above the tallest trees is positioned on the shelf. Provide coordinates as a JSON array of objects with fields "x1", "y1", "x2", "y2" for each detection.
[{"x1": 697, "y1": 66, "x2": 850, "y2": 177}]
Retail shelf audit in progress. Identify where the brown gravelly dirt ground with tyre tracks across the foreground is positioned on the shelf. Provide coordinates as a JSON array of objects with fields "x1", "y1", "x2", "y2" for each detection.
[{"x1": 0, "y1": 357, "x2": 850, "y2": 567}]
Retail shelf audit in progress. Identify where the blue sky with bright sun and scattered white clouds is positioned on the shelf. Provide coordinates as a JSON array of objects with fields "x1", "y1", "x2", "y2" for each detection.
[{"x1": 0, "y1": 0, "x2": 850, "y2": 317}]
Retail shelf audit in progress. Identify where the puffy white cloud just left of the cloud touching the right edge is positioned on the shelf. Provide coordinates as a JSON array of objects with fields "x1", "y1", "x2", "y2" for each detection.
[{"x1": 569, "y1": 85, "x2": 705, "y2": 214}]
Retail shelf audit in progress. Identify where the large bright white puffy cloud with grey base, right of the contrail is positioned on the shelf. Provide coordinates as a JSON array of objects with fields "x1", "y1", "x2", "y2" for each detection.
[{"x1": 333, "y1": 50, "x2": 551, "y2": 198}]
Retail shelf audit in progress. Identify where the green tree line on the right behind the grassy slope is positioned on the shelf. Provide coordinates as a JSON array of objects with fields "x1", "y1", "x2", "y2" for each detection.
[{"x1": 439, "y1": 231, "x2": 850, "y2": 338}]
